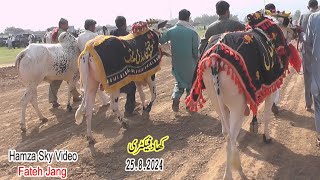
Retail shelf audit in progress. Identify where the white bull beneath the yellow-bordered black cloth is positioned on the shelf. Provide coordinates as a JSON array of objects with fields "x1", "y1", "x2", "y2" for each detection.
[{"x1": 75, "y1": 21, "x2": 167, "y2": 143}]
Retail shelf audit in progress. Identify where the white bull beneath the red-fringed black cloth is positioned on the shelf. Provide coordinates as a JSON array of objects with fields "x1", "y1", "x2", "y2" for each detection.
[{"x1": 190, "y1": 13, "x2": 298, "y2": 179}]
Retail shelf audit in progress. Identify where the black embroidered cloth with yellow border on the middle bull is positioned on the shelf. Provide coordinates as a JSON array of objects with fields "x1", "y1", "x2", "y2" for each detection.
[{"x1": 79, "y1": 30, "x2": 161, "y2": 91}]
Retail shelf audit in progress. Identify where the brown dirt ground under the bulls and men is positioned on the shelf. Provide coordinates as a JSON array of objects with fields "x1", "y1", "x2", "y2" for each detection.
[{"x1": 0, "y1": 58, "x2": 320, "y2": 180}]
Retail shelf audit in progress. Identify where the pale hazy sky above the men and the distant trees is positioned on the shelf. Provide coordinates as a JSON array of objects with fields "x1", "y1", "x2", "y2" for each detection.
[{"x1": 0, "y1": 0, "x2": 308, "y2": 32}]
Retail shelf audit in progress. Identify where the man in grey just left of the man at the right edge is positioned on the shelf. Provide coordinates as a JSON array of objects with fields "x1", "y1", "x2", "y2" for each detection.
[{"x1": 299, "y1": 0, "x2": 318, "y2": 111}]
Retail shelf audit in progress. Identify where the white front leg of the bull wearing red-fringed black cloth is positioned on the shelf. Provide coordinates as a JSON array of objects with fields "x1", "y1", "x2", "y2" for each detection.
[{"x1": 263, "y1": 93, "x2": 276, "y2": 144}]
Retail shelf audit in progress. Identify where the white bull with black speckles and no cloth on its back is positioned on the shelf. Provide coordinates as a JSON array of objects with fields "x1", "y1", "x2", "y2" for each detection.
[{"x1": 15, "y1": 32, "x2": 80, "y2": 131}]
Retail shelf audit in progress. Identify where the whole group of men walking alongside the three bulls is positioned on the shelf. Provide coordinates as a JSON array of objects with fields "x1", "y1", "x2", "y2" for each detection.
[{"x1": 43, "y1": 0, "x2": 320, "y2": 145}]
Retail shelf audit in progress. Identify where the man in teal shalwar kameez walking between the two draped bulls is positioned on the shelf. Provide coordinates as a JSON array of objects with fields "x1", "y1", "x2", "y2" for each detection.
[{"x1": 160, "y1": 9, "x2": 199, "y2": 112}]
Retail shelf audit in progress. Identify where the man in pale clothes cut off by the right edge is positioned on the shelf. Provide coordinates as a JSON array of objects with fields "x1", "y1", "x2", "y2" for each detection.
[{"x1": 305, "y1": 4, "x2": 320, "y2": 146}]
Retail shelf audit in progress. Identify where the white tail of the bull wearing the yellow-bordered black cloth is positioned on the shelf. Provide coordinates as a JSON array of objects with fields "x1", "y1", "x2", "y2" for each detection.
[{"x1": 75, "y1": 53, "x2": 89, "y2": 125}]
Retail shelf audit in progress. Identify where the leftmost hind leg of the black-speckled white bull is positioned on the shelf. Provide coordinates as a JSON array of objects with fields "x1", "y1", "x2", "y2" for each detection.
[{"x1": 20, "y1": 86, "x2": 34, "y2": 132}]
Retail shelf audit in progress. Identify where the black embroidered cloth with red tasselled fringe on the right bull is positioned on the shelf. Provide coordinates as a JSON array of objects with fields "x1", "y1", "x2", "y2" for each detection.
[{"x1": 186, "y1": 13, "x2": 288, "y2": 114}]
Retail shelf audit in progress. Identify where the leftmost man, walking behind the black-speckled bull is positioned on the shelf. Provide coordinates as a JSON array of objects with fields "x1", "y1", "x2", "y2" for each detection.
[{"x1": 49, "y1": 18, "x2": 81, "y2": 108}]
